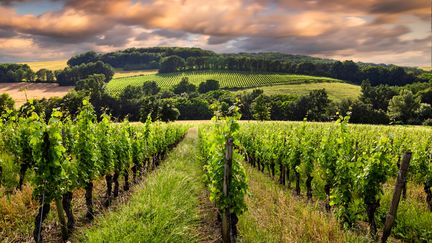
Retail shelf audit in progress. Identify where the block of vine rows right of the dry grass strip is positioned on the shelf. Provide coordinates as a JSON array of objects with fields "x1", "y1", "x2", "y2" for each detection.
[{"x1": 238, "y1": 117, "x2": 432, "y2": 241}]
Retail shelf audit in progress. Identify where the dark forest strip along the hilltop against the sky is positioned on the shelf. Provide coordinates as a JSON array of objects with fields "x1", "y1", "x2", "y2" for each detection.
[{"x1": 68, "y1": 47, "x2": 427, "y2": 85}]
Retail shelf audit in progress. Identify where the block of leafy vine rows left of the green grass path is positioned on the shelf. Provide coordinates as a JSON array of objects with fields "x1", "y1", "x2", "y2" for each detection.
[{"x1": 0, "y1": 100, "x2": 187, "y2": 242}]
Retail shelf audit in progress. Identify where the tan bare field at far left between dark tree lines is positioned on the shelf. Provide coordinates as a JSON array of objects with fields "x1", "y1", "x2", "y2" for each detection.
[{"x1": 0, "y1": 82, "x2": 73, "y2": 107}]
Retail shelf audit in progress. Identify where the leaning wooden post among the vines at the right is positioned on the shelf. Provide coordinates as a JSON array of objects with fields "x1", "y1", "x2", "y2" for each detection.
[{"x1": 381, "y1": 151, "x2": 412, "y2": 242}]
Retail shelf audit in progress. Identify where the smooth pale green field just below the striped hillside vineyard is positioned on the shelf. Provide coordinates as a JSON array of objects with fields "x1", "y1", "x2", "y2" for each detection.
[{"x1": 237, "y1": 83, "x2": 361, "y2": 101}]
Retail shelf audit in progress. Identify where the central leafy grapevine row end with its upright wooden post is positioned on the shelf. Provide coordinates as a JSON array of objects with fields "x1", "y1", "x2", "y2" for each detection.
[{"x1": 199, "y1": 110, "x2": 247, "y2": 242}]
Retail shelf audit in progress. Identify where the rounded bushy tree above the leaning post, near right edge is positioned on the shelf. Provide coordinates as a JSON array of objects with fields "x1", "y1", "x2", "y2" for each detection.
[{"x1": 388, "y1": 89, "x2": 420, "y2": 124}]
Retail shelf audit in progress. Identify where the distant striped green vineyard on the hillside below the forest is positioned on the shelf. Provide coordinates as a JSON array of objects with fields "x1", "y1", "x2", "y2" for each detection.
[{"x1": 107, "y1": 71, "x2": 342, "y2": 95}]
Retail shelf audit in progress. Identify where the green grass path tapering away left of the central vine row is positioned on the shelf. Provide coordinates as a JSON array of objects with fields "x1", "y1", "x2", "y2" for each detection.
[{"x1": 74, "y1": 128, "x2": 220, "y2": 242}]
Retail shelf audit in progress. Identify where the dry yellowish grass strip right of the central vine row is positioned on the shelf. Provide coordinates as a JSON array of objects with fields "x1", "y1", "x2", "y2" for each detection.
[{"x1": 238, "y1": 164, "x2": 367, "y2": 242}]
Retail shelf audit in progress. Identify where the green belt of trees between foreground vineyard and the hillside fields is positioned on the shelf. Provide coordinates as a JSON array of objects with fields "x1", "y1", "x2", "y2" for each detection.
[{"x1": 0, "y1": 74, "x2": 432, "y2": 125}]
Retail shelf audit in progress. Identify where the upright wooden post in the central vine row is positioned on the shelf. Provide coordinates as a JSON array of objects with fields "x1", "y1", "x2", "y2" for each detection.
[{"x1": 222, "y1": 138, "x2": 236, "y2": 243}]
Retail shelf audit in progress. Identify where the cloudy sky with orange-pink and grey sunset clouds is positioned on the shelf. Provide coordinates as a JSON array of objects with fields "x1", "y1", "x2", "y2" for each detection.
[{"x1": 0, "y1": 0, "x2": 432, "y2": 66}]
